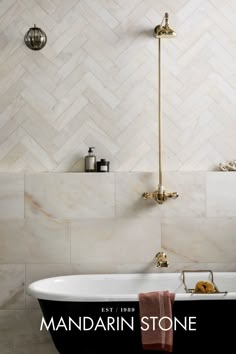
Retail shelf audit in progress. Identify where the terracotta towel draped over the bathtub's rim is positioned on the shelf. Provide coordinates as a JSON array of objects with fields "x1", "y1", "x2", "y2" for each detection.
[{"x1": 139, "y1": 291, "x2": 175, "y2": 352}]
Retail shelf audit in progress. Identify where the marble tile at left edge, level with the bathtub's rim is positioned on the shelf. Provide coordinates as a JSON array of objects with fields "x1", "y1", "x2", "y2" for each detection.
[{"x1": 0, "y1": 264, "x2": 25, "y2": 309}]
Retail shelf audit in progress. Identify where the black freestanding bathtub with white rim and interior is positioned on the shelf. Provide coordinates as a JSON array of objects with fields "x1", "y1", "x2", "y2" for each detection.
[{"x1": 27, "y1": 271, "x2": 236, "y2": 354}]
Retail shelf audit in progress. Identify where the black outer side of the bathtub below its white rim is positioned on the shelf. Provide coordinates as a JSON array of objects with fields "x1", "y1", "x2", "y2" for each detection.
[{"x1": 39, "y1": 299, "x2": 236, "y2": 354}]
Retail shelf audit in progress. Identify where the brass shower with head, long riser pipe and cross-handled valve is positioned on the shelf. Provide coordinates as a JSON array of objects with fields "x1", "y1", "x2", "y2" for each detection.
[{"x1": 142, "y1": 13, "x2": 178, "y2": 204}]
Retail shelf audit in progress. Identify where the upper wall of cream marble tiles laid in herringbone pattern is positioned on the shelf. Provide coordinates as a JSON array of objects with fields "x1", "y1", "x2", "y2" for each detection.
[{"x1": 0, "y1": 0, "x2": 236, "y2": 172}]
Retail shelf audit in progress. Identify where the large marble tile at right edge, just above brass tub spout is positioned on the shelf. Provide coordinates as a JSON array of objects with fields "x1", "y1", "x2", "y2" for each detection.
[{"x1": 161, "y1": 218, "x2": 236, "y2": 263}]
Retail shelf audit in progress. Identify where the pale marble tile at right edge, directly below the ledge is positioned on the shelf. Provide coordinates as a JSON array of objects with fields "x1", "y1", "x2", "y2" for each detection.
[{"x1": 207, "y1": 172, "x2": 236, "y2": 217}]
